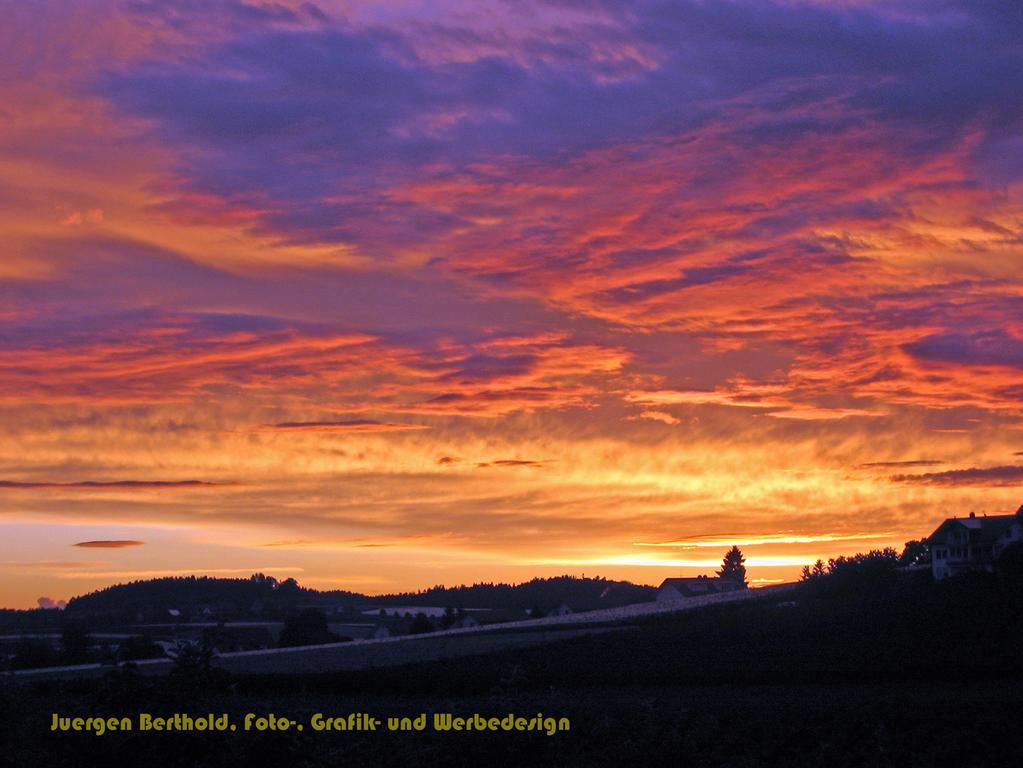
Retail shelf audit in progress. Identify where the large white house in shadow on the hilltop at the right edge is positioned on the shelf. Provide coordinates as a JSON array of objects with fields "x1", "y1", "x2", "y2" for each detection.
[{"x1": 924, "y1": 506, "x2": 1023, "y2": 581}]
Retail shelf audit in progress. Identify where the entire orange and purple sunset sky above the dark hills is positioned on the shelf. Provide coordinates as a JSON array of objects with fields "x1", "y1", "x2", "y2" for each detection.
[{"x1": 0, "y1": 0, "x2": 1023, "y2": 607}]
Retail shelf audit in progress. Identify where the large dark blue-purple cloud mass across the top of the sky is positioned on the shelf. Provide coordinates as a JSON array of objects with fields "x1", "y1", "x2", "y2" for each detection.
[{"x1": 96, "y1": 0, "x2": 1023, "y2": 261}]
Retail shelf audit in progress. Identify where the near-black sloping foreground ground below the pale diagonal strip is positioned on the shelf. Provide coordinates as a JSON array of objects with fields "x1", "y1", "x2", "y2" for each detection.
[{"x1": 0, "y1": 569, "x2": 1023, "y2": 767}]
